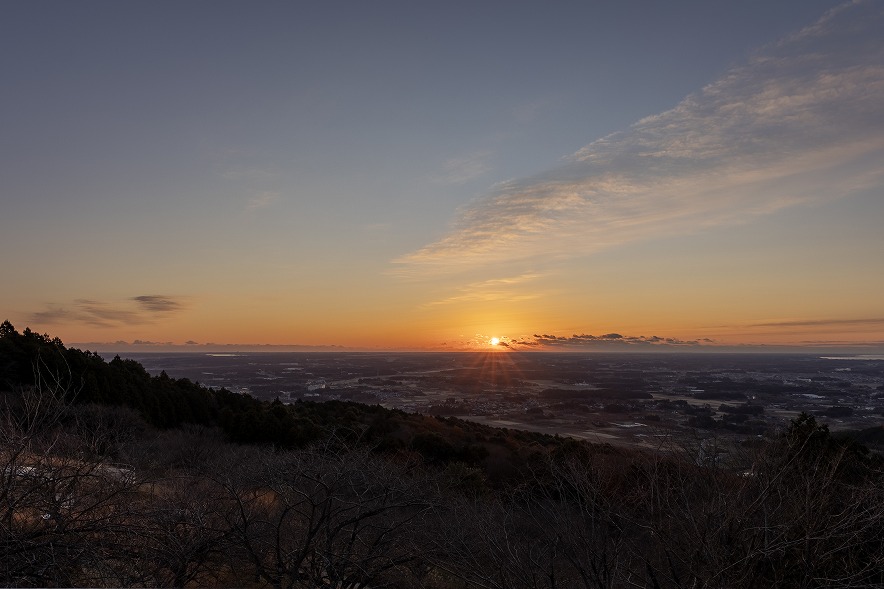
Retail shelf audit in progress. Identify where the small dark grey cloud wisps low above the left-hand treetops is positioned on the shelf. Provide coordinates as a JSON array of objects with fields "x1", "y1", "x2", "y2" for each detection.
[{"x1": 30, "y1": 295, "x2": 186, "y2": 327}]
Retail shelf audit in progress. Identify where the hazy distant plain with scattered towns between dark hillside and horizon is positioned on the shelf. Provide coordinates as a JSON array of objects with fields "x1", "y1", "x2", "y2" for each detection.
[{"x1": 117, "y1": 352, "x2": 884, "y2": 450}]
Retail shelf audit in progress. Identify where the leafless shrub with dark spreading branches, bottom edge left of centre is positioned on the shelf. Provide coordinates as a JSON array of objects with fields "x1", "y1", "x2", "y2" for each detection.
[{"x1": 215, "y1": 438, "x2": 436, "y2": 588}]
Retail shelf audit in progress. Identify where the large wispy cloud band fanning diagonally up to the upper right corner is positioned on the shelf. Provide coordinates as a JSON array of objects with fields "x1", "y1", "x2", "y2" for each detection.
[{"x1": 395, "y1": 1, "x2": 884, "y2": 274}]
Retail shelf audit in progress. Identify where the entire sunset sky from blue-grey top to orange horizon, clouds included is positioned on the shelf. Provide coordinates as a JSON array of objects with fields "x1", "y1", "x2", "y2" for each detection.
[{"x1": 0, "y1": 0, "x2": 884, "y2": 353}]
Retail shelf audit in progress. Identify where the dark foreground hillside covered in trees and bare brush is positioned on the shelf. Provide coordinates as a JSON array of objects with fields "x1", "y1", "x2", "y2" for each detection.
[{"x1": 0, "y1": 322, "x2": 884, "y2": 589}]
